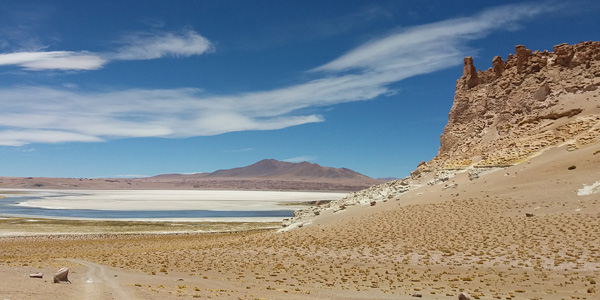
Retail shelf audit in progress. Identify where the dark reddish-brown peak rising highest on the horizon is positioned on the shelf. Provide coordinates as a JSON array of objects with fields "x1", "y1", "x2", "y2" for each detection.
[{"x1": 207, "y1": 159, "x2": 372, "y2": 180}]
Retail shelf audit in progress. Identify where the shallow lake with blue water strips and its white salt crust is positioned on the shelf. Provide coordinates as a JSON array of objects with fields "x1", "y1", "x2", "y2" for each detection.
[{"x1": 0, "y1": 190, "x2": 345, "y2": 221}]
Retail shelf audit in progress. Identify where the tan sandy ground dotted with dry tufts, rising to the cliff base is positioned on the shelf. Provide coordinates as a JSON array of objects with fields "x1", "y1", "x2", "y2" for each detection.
[{"x1": 0, "y1": 143, "x2": 600, "y2": 300}]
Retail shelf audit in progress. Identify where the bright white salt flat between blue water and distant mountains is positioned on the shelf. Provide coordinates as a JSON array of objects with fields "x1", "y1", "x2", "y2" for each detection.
[{"x1": 8, "y1": 190, "x2": 346, "y2": 211}]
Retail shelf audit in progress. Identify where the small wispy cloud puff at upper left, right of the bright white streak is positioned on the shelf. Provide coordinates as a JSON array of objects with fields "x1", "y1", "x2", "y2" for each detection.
[{"x1": 108, "y1": 30, "x2": 214, "y2": 60}]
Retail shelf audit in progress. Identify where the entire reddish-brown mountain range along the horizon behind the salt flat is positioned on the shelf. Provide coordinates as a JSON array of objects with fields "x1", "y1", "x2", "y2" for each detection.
[{"x1": 0, "y1": 159, "x2": 384, "y2": 191}]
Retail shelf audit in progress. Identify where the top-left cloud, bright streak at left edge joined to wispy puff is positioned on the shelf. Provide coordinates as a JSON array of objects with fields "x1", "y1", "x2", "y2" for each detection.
[{"x1": 0, "y1": 30, "x2": 214, "y2": 71}]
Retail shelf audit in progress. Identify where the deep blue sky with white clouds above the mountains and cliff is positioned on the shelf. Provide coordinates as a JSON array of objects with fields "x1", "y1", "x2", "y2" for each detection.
[{"x1": 0, "y1": 0, "x2": 600, "y2": 177}]
